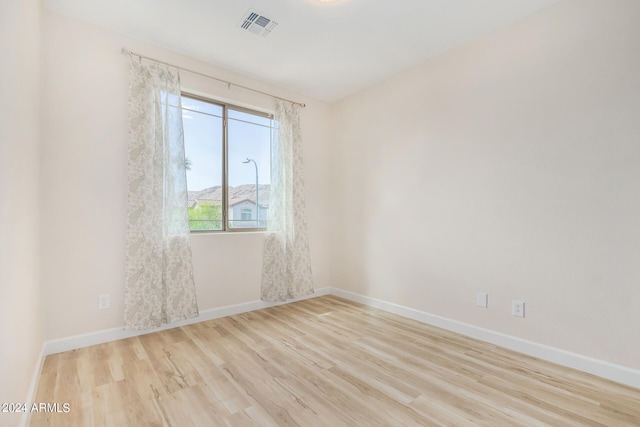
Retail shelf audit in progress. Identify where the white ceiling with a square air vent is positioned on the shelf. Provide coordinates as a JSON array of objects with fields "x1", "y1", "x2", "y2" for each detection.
[{"x1": 43, "y1": 0, "x2": 558, "y2": 102}]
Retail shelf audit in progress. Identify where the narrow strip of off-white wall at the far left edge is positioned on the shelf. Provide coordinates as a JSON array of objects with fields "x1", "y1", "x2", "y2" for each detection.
[{"x1": 0, "y1": 0, "x2": 42, "y2": 426}]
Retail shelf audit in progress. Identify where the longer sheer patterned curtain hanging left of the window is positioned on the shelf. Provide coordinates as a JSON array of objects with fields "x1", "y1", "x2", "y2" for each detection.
[{"x1": 124, "y1": 59, "x2": 198, "y2": 329}]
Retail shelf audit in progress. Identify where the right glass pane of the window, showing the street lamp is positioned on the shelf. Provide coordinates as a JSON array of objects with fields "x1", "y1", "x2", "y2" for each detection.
[{"x1": 227, "y1": 108, "x2": 272, "y2": 228}]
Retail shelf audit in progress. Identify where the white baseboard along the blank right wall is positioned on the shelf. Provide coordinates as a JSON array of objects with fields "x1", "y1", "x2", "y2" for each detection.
[{"x1": 330, "y1": 288, "x2": 640, "y2": 389}]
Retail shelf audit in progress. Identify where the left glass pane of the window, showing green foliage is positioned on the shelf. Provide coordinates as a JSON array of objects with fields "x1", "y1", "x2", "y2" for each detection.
[{"x1": 182, "y1": 96, "x2": 223, "y2": 230}]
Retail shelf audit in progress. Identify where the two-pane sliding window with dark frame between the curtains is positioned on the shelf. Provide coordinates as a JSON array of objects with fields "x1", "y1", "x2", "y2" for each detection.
[{"x1": 182, "y1": 94, "x2": 275, "y2": 231}]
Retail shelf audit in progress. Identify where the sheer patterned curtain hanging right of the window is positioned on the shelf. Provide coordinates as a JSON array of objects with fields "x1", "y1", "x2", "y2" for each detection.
[{"x1": 262, "y1": 100, "x2": 313, "y2": 301}]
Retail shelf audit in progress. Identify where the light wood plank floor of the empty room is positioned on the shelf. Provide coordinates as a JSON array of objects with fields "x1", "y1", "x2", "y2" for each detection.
[{"x1": 31, "y1": 296, "x2": 640, "y2": 427}]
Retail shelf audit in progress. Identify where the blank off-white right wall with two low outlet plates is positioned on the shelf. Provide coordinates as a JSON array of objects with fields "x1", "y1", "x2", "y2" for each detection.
[{"x1": 332, "y1": 0, "x2": 640, "y2": 369}]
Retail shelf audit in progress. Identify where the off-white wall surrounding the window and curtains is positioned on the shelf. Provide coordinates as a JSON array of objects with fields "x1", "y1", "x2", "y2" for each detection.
[{"x1": 41, "y1": 12, "x2": 329, "y2": 340}]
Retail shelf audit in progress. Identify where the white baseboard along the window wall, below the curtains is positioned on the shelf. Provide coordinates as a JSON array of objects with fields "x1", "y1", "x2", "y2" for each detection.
[{"x1": 43, "y1": 288, "x2": 331, "y2": 356}]
